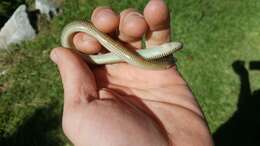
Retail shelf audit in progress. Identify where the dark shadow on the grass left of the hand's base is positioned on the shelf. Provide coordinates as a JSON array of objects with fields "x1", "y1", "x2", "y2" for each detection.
[{"x1": 0, "y1": 102, "x2": 62, "y2": 146}]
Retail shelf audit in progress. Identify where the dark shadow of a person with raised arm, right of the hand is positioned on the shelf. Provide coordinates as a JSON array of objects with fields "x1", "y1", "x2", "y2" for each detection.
[{"x1": 213, "y1": 61, "x2": 260, "y2": 146}]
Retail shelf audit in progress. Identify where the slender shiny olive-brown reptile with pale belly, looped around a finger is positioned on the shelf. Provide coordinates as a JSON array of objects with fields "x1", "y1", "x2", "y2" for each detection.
[{"x1": 61, "y1": 21, "x2": 182, "y2": 70}]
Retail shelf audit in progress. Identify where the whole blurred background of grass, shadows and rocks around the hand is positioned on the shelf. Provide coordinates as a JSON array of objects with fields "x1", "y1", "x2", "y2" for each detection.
[{"x1": 0, "y1": 0, "x2": 260, "y2": 146}]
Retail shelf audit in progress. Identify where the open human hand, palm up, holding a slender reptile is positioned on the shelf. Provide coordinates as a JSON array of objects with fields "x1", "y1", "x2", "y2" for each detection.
[{"x1": 51, "y1": 0, "x2": 213, "y2": 146}]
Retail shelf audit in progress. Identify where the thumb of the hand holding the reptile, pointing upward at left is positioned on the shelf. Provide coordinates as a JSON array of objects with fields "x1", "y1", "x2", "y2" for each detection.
[{"x1": 50, "y1": 48, "x2": 97, "y2": 109}]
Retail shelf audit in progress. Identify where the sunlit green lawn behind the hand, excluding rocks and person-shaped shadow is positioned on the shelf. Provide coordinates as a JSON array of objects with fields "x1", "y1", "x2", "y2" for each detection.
[{"x1": 0, "y1": 0, "x2": 260, "y2": 146}]
